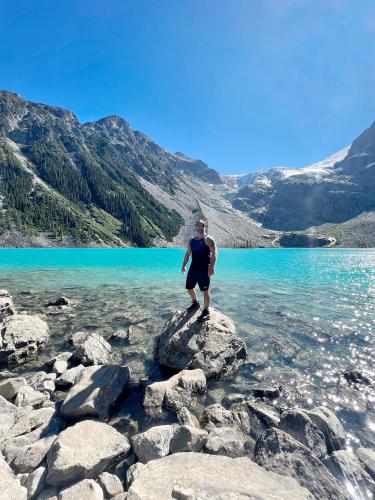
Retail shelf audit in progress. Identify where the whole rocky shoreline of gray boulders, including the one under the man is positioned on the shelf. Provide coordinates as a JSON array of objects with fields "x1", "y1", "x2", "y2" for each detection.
[{"x1": 0, "y1": 290, "x2": 375, "y2": 500}]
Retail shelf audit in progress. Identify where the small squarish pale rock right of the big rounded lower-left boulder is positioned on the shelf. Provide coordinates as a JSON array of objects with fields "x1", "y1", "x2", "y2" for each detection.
[{"x1": 131, "y1": 425, "x2": 174, "y2": 463}]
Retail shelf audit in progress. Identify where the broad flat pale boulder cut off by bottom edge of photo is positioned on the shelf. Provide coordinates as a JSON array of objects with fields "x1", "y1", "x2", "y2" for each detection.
[{"x1": 127, "y1": 453, "x2": 312, "y2": 500}]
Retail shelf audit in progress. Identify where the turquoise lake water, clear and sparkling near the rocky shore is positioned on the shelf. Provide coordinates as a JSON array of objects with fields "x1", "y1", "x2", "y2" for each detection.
[{"x1": 0, "y1": 249, "x2": 375, "y2": 447}]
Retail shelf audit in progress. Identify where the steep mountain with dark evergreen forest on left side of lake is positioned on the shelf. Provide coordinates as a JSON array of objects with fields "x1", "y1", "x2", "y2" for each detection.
[{"x1": 0, "y1": 91, "x2": 272, "y2": 246}]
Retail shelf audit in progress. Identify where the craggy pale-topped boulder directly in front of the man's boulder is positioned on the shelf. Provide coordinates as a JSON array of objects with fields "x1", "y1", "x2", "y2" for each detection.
[{"x1": 143, "y1": 368, "x2": 207, "y2": 413}]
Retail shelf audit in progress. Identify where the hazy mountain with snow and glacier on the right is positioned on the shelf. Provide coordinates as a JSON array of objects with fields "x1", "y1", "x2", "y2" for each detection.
[{"x1": 225, "y1": 123, "x2": 375, "y2": 237}]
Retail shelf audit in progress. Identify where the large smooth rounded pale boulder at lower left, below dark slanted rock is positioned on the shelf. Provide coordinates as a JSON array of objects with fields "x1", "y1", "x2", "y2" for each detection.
[{"x1": 47, "y1": 420, "x2": 130, "y2": 486}]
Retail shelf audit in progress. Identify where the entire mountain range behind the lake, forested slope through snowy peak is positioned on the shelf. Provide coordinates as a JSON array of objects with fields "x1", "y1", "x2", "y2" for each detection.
[{"x1": 0, "y1": 91, "x2": 375, "y2": 247}]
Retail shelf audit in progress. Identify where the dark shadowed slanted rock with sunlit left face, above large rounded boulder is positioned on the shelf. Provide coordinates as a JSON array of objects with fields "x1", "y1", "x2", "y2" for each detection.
[{"x1": 61, "y1": 365, "x2": 131, "y2": 420}]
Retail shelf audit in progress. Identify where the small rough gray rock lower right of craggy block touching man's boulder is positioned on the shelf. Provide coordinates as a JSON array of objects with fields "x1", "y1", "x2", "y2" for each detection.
[{"x1": 201, "y1": 403, "x2": 250, "y2": 434}]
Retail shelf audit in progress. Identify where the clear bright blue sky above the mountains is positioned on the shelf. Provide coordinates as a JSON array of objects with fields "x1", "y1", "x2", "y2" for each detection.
[{"x1": 0, "y1": 0, "x2": 375, "y2": 174}]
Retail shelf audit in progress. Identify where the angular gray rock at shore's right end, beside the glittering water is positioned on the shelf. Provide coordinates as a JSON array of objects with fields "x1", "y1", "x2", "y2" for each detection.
[{"x1": 304, "y1": 406, "x2": 346, "y2": 453}]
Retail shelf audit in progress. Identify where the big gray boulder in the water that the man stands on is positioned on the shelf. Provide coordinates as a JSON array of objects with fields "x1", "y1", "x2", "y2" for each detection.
[{"x1": 156, "y1": 308, "x2": 247, "y2": 378}]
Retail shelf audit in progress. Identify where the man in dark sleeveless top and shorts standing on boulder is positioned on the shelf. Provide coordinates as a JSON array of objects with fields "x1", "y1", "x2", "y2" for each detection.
[{"x1": 181, "y1": 219, "x2": 217, "y2": 321}]
